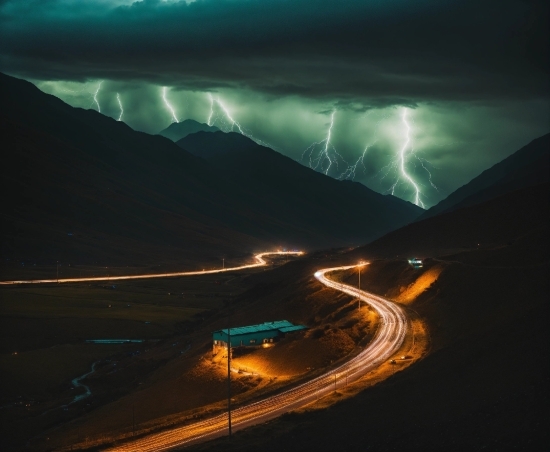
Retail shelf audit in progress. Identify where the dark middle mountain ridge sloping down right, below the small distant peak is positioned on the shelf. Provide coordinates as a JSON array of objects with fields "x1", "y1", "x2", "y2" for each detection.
[{"x1": 177, "y1": 132, "x2": 422, "y2": 243}]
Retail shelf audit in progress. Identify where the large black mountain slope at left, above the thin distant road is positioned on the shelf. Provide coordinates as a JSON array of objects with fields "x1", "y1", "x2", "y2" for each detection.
[{"x1": 0, "y1": 75, "x2": 418, "y2": 272}]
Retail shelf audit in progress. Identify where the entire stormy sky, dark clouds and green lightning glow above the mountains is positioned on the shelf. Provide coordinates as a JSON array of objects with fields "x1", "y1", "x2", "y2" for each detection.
[{"x1": 0, "y1": 0, "x2": 550, "y2": 207}]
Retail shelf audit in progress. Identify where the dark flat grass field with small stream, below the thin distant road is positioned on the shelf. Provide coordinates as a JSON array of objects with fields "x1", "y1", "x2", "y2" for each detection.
[{"x1": 0, "y1": 274, "x2": 254, "y2": 446}]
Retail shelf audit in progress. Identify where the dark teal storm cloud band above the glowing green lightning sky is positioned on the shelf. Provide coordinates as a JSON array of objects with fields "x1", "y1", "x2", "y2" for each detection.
[{"x1": 0, "y1": 0, "x2": 548, "y2": 107}]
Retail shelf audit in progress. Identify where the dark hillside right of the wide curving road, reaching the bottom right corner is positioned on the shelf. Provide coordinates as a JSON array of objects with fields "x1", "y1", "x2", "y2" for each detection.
[{"x1": 193, "y1": 177, "x2": 550, "y2": 451}]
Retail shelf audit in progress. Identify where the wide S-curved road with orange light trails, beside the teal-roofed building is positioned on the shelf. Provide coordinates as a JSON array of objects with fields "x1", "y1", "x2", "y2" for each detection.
[{"x1": 109, "y1": 265, "x2": 408, "y2": 452}]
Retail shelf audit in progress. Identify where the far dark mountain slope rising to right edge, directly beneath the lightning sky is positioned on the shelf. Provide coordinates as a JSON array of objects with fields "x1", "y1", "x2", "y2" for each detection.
[{"x1": 417, "y1": 134, "x2": 550, "y2": 221}]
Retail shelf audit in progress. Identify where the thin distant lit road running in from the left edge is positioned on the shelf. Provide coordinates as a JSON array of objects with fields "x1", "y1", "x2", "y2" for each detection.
[{"x1": 0, "y1": 251, "x2": 303, "y2": 285}]
